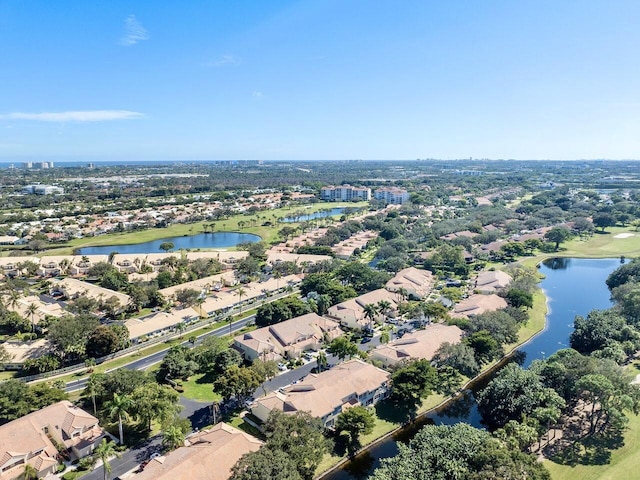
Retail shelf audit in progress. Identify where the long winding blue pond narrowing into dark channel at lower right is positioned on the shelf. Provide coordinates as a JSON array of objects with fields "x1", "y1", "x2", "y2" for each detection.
[{"x1": 322, "y1": 258, "x2": 620, "y2": 480}]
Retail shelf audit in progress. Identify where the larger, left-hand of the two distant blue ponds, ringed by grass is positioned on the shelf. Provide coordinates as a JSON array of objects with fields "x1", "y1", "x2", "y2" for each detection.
[{"x1": 76, "y1": 232, "x2": 262, "y2": 255}]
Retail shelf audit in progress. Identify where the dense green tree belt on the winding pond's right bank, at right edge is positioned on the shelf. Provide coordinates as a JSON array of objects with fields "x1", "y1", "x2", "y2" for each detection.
[{"x1": 462, "y1": 260, "x2": 640, "y2": 461}]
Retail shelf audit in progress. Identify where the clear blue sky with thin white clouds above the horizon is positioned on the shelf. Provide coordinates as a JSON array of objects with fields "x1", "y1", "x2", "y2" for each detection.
[{"x1": 0, "y1": 0, "x2": 640, "y2": 161}]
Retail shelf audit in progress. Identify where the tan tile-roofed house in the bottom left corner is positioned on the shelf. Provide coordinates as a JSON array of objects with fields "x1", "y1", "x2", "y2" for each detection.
[{"x1": 0, "y1": 400, "x2": 105, "y2": 480}]
